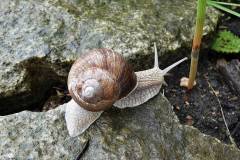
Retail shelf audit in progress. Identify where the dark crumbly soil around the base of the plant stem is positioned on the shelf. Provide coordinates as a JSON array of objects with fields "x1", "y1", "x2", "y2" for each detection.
[{"x1": 164, "y1": 53, "x2": 240, "y2": 146}]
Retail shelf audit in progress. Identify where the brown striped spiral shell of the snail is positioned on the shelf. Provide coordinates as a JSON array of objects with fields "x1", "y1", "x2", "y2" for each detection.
[{"x1": 68, "y1": 49, "x2": 137, "y2": 112}]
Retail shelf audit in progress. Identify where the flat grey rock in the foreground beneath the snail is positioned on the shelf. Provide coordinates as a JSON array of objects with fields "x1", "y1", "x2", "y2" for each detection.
[{"x1": 0, "y1": 94, "x2": 240, "y2": 160}]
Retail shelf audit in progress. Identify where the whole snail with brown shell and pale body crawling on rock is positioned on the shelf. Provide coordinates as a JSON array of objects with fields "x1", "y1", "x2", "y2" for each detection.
[{"x1": 65, "y1": 43, "x2": 187, "y2": 137}]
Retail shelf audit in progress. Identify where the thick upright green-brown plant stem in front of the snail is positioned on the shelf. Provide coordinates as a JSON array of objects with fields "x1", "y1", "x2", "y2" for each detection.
[{"x1": 188, "y1": 0, "x2": 207, "y2": 89}]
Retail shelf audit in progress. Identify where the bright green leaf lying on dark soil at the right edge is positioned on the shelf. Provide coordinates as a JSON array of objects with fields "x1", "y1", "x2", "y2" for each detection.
[{"x1": 211, "y1": 30, "x2": 240, "y2": 54}]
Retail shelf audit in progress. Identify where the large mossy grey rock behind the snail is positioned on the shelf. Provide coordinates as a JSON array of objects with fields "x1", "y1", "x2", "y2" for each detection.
[{"x1": 0, "y1": 0, "x2": 218, "y2": 115}]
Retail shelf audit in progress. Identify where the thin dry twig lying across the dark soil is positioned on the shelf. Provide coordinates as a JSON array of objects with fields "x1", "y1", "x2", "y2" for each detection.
[{"x1": 204, "y1": 76, "x2": 237, "y2": 147}]
